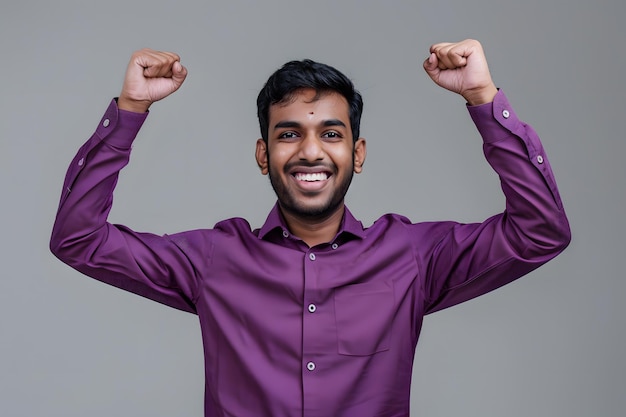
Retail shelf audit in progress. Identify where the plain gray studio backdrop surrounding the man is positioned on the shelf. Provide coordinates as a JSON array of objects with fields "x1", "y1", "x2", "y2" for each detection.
[{"x1": 0, "y1": 0, "x2": 626, "y2": 417}]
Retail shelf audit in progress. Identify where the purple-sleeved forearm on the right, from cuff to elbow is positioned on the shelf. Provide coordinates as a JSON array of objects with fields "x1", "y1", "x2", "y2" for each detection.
[{"x1": 469, "y1": 92, "x2": 570, "y2": 260}]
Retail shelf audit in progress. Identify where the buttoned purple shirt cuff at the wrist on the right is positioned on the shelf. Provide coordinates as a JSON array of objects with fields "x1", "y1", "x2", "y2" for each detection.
[{"x1": 467, "y1": 90, "x2": 522, "y2": 143}]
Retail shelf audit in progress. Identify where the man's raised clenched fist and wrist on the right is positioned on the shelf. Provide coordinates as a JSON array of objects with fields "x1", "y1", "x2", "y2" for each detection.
[{"x1": 424, "y1": 39, "x2": 498, "y2": 105}]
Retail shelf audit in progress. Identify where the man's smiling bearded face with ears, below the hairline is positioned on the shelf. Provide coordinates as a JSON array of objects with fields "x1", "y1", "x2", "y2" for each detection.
[{"x1": 256, "y1": 89, "x2": 366, "y2": 219}]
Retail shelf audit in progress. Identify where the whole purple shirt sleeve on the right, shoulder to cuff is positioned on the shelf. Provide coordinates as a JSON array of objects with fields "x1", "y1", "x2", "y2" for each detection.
[{"x1": 421, "y1": 91, "x2": 571, "y2": 313}]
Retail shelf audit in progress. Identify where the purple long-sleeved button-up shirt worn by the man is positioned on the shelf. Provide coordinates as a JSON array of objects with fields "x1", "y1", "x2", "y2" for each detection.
[{"x1": 51, "y1": 92, "x2": 570, "y2": 417}]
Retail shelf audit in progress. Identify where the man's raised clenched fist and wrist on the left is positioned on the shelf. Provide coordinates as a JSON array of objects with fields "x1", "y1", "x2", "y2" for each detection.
[{"x1": 117, "y1": 49, "x2": 187, "y2": 113}]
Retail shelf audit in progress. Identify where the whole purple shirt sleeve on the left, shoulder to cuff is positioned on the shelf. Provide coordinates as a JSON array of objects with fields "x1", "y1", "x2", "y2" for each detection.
[{"x1": 50, "y1": 100, "x2": 202, "y2": 313}]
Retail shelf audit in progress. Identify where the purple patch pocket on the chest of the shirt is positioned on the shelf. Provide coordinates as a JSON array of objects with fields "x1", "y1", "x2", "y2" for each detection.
[{"x1": 334, "y1": 282, "x2": 394, "y2": 356}]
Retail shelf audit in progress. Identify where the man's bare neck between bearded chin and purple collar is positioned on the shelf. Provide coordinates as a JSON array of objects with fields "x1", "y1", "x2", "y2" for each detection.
[{"x1": 281, "y1": 204, "x2": 344, "y2": 247}]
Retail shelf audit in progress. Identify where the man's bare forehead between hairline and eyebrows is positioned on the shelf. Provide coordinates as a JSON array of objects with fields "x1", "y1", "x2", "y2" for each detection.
[{"x1": 269, "y1": 88, "x2": 350, "y2": 125}]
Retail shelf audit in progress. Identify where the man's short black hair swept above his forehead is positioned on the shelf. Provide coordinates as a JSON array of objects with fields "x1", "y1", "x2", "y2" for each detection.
[{"x1": 257, "y1": 59, "x2": 363, "y2": 143}]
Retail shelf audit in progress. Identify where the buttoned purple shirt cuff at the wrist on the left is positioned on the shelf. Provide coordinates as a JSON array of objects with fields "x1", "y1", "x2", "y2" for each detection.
[{"x1": 96, "y1": 99, "x2": 149, "y2": 149}]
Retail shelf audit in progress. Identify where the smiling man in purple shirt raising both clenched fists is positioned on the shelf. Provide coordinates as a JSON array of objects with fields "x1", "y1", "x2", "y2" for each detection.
[{"x1": 51, "y1": 40, "x2": 570, "y2": 417}]
